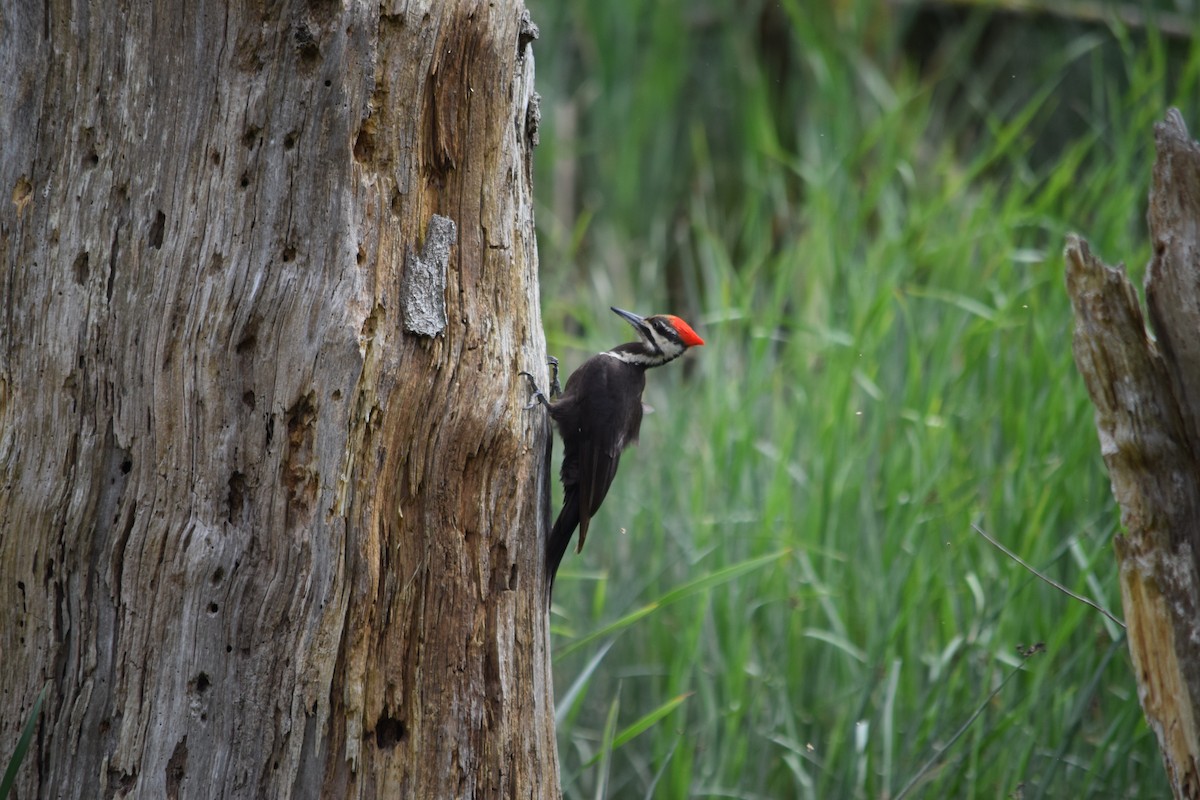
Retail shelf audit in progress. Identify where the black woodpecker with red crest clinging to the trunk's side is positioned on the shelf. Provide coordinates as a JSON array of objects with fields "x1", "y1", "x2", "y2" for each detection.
[{"x1": 521, "y1": 308, "x2": 704, "y2": 599}]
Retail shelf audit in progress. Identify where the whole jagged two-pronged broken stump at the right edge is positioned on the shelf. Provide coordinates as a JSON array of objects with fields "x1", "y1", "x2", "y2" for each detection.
[{"x1": 1066, "y1": 109, "x2": 1200, "y2": 798}]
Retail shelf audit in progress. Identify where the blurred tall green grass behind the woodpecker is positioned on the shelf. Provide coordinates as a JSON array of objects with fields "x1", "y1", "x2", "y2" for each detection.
[{"x1": 529, "y1": 0, "x2": 1200, "y2": 799}]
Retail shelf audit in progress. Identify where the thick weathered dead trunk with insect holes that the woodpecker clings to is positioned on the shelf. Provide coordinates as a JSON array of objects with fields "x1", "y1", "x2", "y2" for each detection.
[{"x1": 0, "y1": 0, "x2": 558, "y2": 799}]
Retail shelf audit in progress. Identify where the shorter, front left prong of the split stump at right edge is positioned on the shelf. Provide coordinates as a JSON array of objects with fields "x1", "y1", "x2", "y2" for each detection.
[{"x1": 1066, "y1": 236, "x2": 1200, "y2": 798}]
